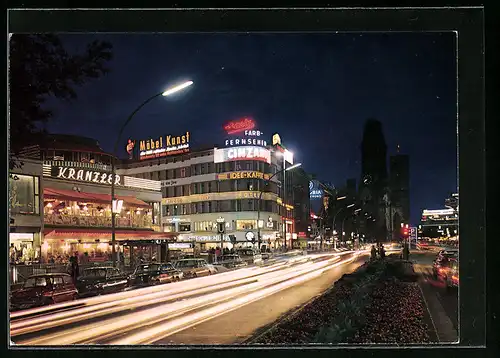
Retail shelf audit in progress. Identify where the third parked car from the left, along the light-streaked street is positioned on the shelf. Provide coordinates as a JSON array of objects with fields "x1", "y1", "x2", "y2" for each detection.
[{"x1": 128, "y1": 263, "x2": 184, "y2": 286}]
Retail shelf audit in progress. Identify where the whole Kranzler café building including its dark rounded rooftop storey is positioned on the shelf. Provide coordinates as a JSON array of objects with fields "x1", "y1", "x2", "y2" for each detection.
[{"x1": 11, "y1": 135, "x2": 166, "y2": 265}]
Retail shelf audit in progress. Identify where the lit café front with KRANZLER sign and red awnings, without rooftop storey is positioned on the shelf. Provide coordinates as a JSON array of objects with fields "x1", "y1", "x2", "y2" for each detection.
[{"x1": 41, "y1": 162, "x2": 164, "y2": 264}]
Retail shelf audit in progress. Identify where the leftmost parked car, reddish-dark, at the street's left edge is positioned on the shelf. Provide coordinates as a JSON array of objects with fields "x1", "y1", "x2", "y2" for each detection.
[{"x1": 10, "y1": 273, "x2": 78, "y2": 310}]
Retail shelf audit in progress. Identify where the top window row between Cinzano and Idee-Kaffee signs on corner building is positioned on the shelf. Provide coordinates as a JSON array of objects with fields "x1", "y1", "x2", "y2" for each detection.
[{"x1": 134, "y1": 160, "x2": 276, "y2": 180}]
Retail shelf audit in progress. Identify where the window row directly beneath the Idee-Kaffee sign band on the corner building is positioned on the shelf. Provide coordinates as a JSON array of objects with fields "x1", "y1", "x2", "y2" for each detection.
[{"x1": 161, "y1": 179, "x2": 280, "y2": 198}]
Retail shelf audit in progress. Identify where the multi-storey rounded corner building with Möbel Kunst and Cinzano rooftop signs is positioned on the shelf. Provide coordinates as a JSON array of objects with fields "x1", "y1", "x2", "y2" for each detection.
[{"x1": 117, "y1": 118, "x2": 295, "y2": 251}]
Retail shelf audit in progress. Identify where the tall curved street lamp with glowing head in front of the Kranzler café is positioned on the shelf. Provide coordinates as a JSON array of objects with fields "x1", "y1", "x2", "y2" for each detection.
[{"x1": 111, "y1": 81, "x2": 193, "y2": 267}]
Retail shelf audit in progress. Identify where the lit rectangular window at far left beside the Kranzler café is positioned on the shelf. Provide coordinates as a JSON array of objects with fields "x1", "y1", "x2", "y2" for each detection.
[{"x1": 9, "y1": 174, "x2": 40, "y2": 214}]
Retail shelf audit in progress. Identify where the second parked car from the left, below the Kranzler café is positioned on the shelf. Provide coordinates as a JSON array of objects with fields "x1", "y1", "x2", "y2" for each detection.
[{"x1": 76, "y1": 267, "x2": 128, "y2": 297}]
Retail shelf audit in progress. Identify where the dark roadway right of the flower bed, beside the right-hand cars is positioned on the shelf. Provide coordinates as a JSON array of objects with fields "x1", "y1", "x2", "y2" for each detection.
[{"x1": 410, "y1": 250, "x2": 458, "y2": 342}]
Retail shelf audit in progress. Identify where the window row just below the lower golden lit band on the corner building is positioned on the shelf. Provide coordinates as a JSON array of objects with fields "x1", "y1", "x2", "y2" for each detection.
[{"x1": 162, "y1": 199, "x2": 286, "y2": 216}]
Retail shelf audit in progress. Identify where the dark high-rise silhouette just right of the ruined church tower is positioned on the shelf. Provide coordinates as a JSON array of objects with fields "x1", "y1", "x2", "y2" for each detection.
[{"x1": 389, "y1": 154, "x2": 410, "y2": 223}]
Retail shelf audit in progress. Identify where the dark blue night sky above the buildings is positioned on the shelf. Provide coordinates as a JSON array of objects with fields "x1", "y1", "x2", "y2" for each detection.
[{"x1": 48, "y1": 33, "x2": 457, "y2": 224}]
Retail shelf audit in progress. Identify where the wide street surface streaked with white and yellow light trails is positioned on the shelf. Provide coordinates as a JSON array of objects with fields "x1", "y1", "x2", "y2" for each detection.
[{"x1": 10, "y1": 251, "x2": 367, "y2": 346}]
